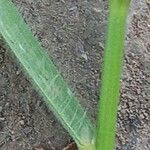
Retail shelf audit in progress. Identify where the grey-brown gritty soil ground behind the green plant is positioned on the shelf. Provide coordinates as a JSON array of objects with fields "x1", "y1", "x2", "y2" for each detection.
[{"x1": 0, "y1": 0, "x2": 150, "y2": 150}]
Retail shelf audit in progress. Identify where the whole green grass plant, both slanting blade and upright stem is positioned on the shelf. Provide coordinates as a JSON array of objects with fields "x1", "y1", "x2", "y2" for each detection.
[{"x1": 0, "y1": 0, "x2": 130, "y2": 150}]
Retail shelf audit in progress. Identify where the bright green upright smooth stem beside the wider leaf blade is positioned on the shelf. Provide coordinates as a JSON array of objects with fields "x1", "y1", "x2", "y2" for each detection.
[{"x1": 96, "y1": 0, "x2": 130, "y2": 150}]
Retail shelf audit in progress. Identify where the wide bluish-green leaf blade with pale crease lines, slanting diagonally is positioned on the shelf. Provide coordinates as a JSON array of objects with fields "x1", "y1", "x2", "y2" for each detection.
[{"x1": 0, "y1": 0, "x2": 94, "y2": 150}]
